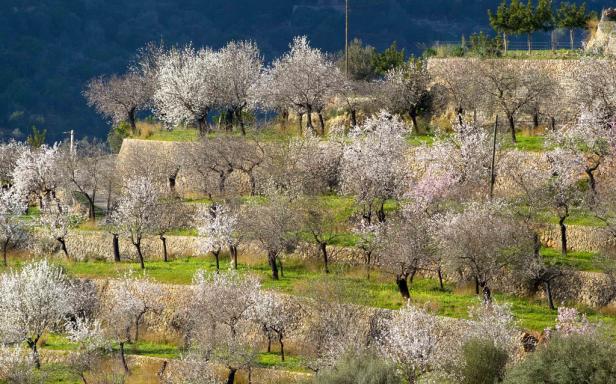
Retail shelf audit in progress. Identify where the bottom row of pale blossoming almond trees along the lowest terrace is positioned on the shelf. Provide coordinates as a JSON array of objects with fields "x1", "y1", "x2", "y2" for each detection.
[{"x1": 0, "y1": 261, "x2": 613, "y2": 384}]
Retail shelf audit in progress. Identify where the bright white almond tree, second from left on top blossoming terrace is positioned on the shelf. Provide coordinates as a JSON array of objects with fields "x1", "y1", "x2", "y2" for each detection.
[{"x1": 154, "y1": 45, "x2": 219, "y2": 134}]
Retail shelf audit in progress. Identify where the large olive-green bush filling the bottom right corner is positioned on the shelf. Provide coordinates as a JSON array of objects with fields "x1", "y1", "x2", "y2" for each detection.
[{"x1": 505, "y1": 335, "x2": 616, "y2": 384}]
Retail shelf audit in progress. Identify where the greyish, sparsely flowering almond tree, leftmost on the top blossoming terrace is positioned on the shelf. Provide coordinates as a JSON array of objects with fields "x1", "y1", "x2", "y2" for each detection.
[{"x1": 83, "y1": 72, "x2": 151, "y2": 134}]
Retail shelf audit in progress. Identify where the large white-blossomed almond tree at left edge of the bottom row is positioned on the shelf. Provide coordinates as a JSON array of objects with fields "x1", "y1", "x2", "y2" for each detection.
[{"x1": 0, "y1": 260, "x2": 73, "y2": 368}]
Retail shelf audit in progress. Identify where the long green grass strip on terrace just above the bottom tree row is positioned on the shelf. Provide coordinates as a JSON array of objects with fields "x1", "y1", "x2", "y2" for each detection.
[{"x1": 0, "y1": 255, "x2": 616, "y2": 336}]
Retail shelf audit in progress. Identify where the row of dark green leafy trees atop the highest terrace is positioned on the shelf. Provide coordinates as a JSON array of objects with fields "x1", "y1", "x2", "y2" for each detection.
[{"x1": 488, "y1": 0, "x2": 596, "y2": 53}]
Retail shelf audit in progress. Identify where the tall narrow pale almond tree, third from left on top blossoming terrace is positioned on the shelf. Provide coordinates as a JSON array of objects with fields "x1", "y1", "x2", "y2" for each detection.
[{"x1": 215, "y1": 41, "x2": 263, "y2": 135}]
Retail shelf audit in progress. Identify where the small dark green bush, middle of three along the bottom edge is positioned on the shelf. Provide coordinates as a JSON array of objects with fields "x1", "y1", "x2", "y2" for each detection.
[{"x1": 461, "y1": 339, "x2": 509, "y2": 384}]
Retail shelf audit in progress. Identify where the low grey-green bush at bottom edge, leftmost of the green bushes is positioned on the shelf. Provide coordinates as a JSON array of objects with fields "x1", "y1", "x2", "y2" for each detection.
[{"x1": 315, "y1": 353, "x2": 402, "y2": 384}]
